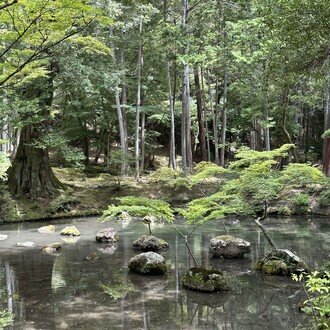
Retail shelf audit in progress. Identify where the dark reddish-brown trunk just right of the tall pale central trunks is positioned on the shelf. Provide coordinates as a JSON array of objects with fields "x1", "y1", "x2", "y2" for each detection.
[{"x1": 194, "y1": 65, "x2": 207, "y2": 161}]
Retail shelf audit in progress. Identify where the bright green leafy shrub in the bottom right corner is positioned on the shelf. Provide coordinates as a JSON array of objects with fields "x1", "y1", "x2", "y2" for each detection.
[{"x1": 292, "y1": 271, "x2": 330, "y2": 329}]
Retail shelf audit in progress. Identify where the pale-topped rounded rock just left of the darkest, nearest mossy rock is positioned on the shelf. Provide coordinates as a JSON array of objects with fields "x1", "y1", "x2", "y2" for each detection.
[{"x1": 128, "y1": 252, "x2": 167, "y2": 275}]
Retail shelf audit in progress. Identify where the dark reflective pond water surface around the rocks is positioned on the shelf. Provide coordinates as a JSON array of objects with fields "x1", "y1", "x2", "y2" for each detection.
[{"x1": 0, "y1": 218, "x2": 330, "y2": 330}]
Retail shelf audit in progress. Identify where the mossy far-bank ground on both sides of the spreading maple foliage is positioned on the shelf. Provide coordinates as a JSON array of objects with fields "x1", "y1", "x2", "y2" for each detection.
[{"x1": 0, "y1": 167, "x2": 330, "y2": 222}]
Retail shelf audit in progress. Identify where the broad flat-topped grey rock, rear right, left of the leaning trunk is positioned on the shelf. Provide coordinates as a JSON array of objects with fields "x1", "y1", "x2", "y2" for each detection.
[{"x1": 210, "y1": 235, "x2": 251, "y2": 259}]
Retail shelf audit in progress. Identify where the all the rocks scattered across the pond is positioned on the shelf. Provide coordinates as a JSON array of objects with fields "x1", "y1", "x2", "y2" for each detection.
[{"x1": 0, "y1": 218, "x2": 309, "y2": 292}]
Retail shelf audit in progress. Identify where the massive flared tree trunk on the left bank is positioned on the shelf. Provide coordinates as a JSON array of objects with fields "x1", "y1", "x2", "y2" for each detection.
[{"x1": 8, "y1": 125, "x2": 62, "y2": 199}]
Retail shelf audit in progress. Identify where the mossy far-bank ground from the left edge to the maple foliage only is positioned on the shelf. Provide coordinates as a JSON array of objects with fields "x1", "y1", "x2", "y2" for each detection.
[{"x1": 0, "y1": 168, "x2": 219, "y2": 222}]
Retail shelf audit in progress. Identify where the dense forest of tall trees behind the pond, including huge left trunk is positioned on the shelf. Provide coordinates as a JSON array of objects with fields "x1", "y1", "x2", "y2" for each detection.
[{"x1": 0, "y1": 0, "x2": 330, "y2": 199}]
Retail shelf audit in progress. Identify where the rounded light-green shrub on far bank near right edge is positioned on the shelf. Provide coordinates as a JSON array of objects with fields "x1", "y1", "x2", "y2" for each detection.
[{"x1": 280, "y1": 164, "x2": 325, "y2": 187}]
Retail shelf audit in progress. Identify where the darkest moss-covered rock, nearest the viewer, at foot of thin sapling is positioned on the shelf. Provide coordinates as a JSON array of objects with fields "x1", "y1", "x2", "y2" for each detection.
[{"x1": 182, "y1": 267, "x2": 229, "y2": 292}]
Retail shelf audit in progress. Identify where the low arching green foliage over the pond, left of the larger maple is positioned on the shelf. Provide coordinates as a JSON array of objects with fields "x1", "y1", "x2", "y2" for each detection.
[{"x1": 102, "y1": 196, "x2": 174, "y2": 222}]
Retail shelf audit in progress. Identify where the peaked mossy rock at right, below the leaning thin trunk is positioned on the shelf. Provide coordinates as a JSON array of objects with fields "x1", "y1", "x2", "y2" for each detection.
[{"x1": 254, "y1": 250, "x2": 310, "y2": 276}]
